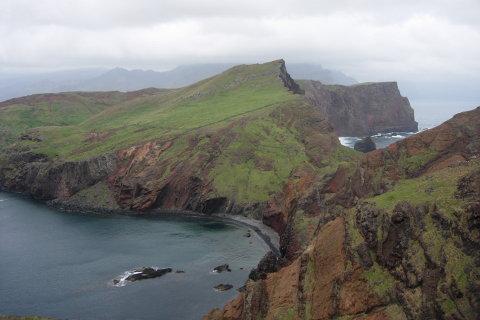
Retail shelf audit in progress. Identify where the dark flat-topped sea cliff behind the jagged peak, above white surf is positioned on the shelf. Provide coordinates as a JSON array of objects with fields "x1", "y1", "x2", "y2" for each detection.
[{"x1": 299, "y1": 80, "x2": 418, "y2": 136}]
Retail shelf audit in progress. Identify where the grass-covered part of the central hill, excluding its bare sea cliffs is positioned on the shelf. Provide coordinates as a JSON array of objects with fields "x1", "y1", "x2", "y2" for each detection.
[{"x1": 0, "y1": 60, "x2": 355, "y2": 209}]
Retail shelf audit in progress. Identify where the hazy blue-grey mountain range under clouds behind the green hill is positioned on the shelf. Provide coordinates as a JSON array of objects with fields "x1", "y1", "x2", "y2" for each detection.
[{"x1": 0, "y1": 63, "x2": 357, "y2": 101}]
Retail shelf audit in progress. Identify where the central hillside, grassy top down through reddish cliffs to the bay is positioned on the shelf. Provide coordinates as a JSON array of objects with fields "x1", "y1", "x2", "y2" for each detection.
[{"x1": 0, "y1": 60, "x2": 355, "y2": 212}]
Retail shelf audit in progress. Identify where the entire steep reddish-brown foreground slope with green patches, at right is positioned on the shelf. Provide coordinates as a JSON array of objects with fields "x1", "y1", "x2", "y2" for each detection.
[{"x1": 205, "y1": 107, "x2": 480, "y2": 319}]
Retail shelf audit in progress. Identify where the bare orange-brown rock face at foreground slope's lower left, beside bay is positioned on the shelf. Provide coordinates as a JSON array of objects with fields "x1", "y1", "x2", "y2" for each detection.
[{"x1": 206, "y1": 218, "x2": 382, "y2": 319}]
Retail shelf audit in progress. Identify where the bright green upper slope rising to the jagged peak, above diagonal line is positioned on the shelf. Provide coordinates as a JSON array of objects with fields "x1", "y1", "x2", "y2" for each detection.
[{"x1": 16, "y1": 61, "x2": 296, "y2": 160}]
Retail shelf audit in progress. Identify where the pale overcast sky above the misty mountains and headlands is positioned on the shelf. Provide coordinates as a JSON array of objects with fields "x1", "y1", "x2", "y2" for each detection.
[{"x1": 0, "y1": 0, "x2": 480, "y2": 103}]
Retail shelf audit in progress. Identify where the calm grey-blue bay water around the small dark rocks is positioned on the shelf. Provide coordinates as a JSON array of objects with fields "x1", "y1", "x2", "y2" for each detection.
[{"x1": 0, "y1": 192, "x2": 268, "y2": 320}]
